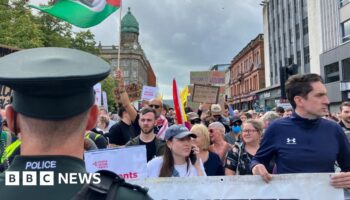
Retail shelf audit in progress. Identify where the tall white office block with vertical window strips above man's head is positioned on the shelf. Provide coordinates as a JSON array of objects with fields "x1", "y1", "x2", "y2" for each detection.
[{"x1": 258, "y1": 0, "x2": 321, "y2": 110}]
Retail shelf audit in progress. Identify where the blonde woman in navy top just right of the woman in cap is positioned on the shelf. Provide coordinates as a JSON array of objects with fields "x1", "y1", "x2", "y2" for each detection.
[{"x1": 191, "y1": 124, "x2": 225, "y2": 176}]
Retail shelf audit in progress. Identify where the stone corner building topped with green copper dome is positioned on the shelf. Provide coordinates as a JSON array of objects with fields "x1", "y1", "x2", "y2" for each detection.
[{"x1": 98, "y1": 8, "x2": 157, "y2": 87}]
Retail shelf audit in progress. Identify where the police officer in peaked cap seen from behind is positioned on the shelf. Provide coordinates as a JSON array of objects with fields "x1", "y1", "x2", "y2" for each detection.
[{"x1": 0, "y1": 48, "x2": 152, "y2": 199}]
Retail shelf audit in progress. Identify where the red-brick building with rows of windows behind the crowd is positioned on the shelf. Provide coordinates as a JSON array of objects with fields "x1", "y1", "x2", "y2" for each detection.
[{"x1": 229, "y1": 34, "x2": 265, "y2": 110}]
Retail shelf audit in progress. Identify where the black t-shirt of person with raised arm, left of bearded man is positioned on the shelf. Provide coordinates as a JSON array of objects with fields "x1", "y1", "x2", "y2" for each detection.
[{"x1": 105, "y1": 121, "x2": 140, "y2": 145}]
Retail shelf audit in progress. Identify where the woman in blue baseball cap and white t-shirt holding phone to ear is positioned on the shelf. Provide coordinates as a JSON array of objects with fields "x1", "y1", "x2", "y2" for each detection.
[{"x1": 147, "y1": 125, "x2": 206, "y2": 177}]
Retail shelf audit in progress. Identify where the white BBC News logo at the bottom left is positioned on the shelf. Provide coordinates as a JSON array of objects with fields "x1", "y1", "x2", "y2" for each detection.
[{"x1": 5, "y1": 171, "x2": 101, "y2": 186}]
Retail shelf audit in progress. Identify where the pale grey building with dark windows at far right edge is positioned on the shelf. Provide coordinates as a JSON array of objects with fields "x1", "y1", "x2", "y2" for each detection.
[{"x1": 320, "y1": 0, "x2": 350, "y2": 113}]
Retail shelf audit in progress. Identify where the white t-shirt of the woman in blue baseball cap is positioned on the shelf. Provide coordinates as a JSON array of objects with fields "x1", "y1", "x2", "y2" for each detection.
[{"x1": 147, "y1": 156, "x2": 206, "y2": 177}]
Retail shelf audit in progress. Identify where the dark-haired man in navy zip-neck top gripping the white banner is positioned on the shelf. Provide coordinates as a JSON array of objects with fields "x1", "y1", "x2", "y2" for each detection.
[{"x1": 251, "y1": 74, "x2": 350, "y2": 188}]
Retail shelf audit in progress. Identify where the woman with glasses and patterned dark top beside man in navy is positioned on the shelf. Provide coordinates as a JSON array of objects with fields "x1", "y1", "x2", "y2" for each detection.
[{"x1": 225, "y1": 119, "x2": 263, "y2": 175}]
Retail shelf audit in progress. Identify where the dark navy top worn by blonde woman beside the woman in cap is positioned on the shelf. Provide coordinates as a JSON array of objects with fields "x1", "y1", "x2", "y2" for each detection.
[{"x1": 204, "y1": 151, "x2": 225, "y2": 176}]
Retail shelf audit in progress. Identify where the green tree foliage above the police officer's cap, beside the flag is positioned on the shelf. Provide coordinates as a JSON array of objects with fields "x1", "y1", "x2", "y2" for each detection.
[{"x1": 0, "y1": 0, "x2": 98, "y2": 54}]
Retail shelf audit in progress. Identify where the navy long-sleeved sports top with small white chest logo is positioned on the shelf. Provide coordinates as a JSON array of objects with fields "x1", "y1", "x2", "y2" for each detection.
[{"x1": 250, "y1": 113, "x2": 350, "y2": 174}]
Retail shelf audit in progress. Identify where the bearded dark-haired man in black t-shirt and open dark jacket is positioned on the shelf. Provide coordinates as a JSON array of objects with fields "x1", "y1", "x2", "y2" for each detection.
[{"x1": 126, "y1": 107, "x2": 165, "y2": 162}]
